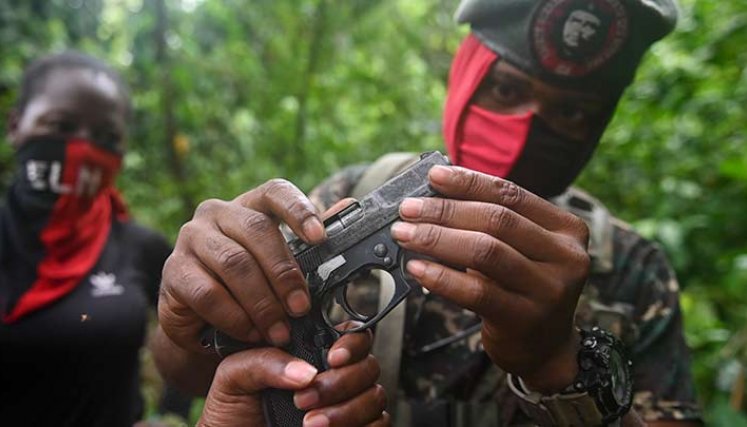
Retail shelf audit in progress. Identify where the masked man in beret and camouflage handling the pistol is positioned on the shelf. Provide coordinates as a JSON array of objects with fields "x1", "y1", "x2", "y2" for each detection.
[{"x1": 152, "y1": 0, "x2": 700, "y2": 426}]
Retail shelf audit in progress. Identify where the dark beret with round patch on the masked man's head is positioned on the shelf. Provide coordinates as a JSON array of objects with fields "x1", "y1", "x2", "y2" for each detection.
[{"x1": 455, "y1": 0, "x2": 677, "y2": 94}]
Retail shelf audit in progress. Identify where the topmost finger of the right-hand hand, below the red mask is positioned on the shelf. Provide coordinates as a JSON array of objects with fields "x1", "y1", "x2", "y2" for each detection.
[{"x1": 428, "y1": 166, "x2": 579, "y2": 231}]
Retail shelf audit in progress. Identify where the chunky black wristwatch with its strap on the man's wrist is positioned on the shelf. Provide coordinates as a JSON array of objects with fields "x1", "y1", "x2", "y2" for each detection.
[{"x1": 508, "y1": 327, "x2": 633, "y2": 427}]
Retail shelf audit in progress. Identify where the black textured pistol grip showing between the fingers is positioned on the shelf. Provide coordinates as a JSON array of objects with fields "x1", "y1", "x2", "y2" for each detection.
[{"x1": 262, "y1": 307, "x2": 337, "y2": 427}]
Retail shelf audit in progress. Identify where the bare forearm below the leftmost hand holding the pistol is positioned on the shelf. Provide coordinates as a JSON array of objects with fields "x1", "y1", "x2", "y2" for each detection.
[{"x1": 150, "y1": 326, "x2": 220, "y2": 396}]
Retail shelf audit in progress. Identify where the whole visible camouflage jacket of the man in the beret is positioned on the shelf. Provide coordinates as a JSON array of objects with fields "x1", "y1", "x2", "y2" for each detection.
[{"x1": 309, "y1": 161, "x2": 701, "y2": 426}]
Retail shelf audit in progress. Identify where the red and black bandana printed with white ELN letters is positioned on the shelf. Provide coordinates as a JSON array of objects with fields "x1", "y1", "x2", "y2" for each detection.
[{"x1": 0, "y1": 137, "x2": 127, "y2": 323}]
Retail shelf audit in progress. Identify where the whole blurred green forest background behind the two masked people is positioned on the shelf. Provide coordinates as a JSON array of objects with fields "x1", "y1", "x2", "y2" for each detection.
[{"x1": 0, "y1": 0, "x2": 747, "y2": 426}]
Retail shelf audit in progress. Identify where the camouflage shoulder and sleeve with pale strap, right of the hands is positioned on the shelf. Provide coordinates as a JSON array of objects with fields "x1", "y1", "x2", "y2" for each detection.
[{"x1": 556, "y1": 189, "x2": 702, "y2": 421}]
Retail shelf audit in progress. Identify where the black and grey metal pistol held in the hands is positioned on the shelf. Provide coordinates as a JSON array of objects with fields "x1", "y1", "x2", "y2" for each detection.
[{"x1": 202, "y1": 151, "x2": 450, "y2": 427}]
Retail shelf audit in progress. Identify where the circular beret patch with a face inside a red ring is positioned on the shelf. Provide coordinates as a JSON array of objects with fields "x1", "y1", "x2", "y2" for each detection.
[{"x1": 531, "y1": 0, "x2": 628, "y2": 77}]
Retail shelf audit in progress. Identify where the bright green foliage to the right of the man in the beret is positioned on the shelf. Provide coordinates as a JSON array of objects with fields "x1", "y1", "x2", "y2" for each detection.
[{"x1": 581, "y1": 0, "x2": 747, "y2": 426}]
